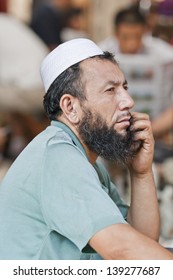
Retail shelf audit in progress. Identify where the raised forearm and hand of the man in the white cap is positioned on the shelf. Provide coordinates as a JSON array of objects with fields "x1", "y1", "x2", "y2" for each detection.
[{"x1": 128, "y1": 112, "x2": 160, "y2": 240}]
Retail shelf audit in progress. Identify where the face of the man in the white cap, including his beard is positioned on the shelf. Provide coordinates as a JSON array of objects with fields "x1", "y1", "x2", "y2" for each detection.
[{"x1": 78, "y1": 59, "x2": 137, "y2": 162}]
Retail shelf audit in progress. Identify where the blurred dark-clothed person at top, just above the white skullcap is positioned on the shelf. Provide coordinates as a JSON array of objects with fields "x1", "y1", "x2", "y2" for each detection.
[{"x1": 30, "y1": 0, "x2": 71, "y2": 50}]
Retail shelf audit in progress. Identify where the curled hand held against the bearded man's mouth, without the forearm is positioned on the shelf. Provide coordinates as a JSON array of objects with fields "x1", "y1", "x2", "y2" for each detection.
[{"x1": 128, "y1": 112, "x2": 154, "y2": 175}]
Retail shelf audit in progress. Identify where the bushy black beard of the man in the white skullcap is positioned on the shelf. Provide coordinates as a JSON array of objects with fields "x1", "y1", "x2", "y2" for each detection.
[{"x1": 78, "y1": 108, "x2": 136, "y2": 164}]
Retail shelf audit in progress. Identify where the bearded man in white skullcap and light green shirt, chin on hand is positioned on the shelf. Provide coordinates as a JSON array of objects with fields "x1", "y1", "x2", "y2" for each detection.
[{"x1": 0, "y1": 39, "x2": 173, "y2": 259}]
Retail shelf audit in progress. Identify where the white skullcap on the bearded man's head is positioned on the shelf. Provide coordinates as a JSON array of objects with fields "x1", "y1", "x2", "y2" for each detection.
[{"x1": 41, "y1": 38, "x2": 103, "y2": 92}]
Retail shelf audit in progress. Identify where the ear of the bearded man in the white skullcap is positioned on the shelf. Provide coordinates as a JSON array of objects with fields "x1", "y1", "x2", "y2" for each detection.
[{"x1": 60, "y1": 94, "x2": 79, "y2": 124}]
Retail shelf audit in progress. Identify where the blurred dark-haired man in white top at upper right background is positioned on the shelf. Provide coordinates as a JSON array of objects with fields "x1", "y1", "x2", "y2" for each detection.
[{"x1": 99, "y1": 6, "x2": 173, "y2": 56}]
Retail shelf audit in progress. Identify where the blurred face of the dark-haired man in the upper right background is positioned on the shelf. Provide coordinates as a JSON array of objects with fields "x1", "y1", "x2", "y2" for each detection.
[{"x1": 116, "y1": 23, "x2": 145, "y2": 54}]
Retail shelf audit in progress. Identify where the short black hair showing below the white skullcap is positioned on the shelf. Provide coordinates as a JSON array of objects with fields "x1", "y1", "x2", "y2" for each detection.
[{"x1": 43, "y1": 52, "x2": 117, "y2": 120}]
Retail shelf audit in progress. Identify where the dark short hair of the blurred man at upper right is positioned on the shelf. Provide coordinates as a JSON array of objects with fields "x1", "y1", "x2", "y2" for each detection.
[{"x1": 114, "y1": 7, "x2": 146, "y2": 27}]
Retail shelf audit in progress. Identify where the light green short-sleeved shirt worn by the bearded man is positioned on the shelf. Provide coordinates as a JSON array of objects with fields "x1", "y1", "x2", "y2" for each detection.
[{"x1": 0, "y1": 121, "x2": 128, "y2": 260}]
